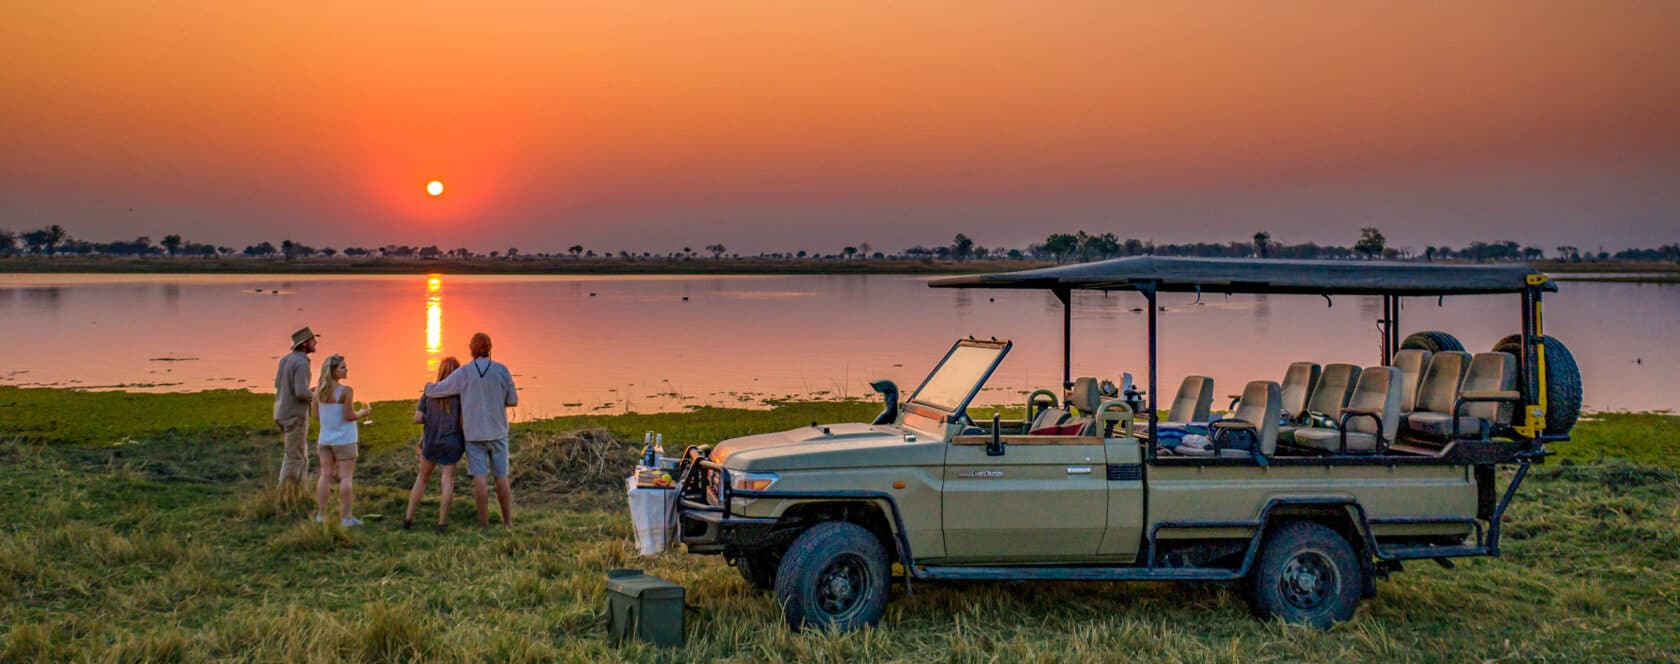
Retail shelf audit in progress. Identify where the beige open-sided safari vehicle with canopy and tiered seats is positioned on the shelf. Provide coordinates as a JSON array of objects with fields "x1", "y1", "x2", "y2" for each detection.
[{"x1": 677, "y1": 257, "x2": 1581, "y2": 629}]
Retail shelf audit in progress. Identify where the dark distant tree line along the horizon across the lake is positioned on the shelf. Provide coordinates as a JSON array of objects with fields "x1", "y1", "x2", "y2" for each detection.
[{"x1": 0, "y1": 224, "x2": 1680, "y2": 262}]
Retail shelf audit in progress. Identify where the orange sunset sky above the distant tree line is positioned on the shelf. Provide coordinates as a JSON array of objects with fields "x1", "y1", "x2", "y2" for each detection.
[{"x1": 0, "y1": 0, "x2": 1680, "y2": 252}]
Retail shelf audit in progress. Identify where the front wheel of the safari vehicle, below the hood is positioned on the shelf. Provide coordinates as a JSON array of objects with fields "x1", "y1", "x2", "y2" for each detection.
[{"x1": 776, "y1": 521, "x2": 892, "y2": 632}]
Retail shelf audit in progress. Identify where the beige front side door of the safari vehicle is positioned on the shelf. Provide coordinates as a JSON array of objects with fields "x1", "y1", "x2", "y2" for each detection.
[{"x1": 942, "y1": 435, "x2": 1109, "y2": 563}]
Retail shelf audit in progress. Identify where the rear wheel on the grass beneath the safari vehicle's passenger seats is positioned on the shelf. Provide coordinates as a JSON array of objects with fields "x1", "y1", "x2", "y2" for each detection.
[{"x1": 1248, "y1": 521, "x2": 1364, "y2": 629}]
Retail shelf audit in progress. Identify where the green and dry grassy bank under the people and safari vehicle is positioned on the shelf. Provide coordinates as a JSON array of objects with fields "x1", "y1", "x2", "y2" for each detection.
[{"x1": 0, "y1": 388, "x2": 1680, "y2": 662}]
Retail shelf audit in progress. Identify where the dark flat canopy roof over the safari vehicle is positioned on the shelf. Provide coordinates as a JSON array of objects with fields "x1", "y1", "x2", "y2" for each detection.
[{"x1": 927, "y1": 256, "x2": 1557, "y2": 296}]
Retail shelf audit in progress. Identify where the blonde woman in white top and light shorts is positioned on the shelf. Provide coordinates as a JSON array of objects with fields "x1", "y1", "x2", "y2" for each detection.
[{"x1": 314, "y1": 355, "x2": 373, "y2": 528}]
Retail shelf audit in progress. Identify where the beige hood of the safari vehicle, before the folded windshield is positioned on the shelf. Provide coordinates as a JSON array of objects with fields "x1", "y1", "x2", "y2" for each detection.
[{"x1": 711, "y1": 424, "x2": 924, "y2": 471}]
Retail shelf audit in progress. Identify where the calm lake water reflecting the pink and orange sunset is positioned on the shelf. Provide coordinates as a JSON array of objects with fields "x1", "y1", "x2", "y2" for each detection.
[{"x1": 0, "y1": 274, "x2": 1680, "y2": 419}]
